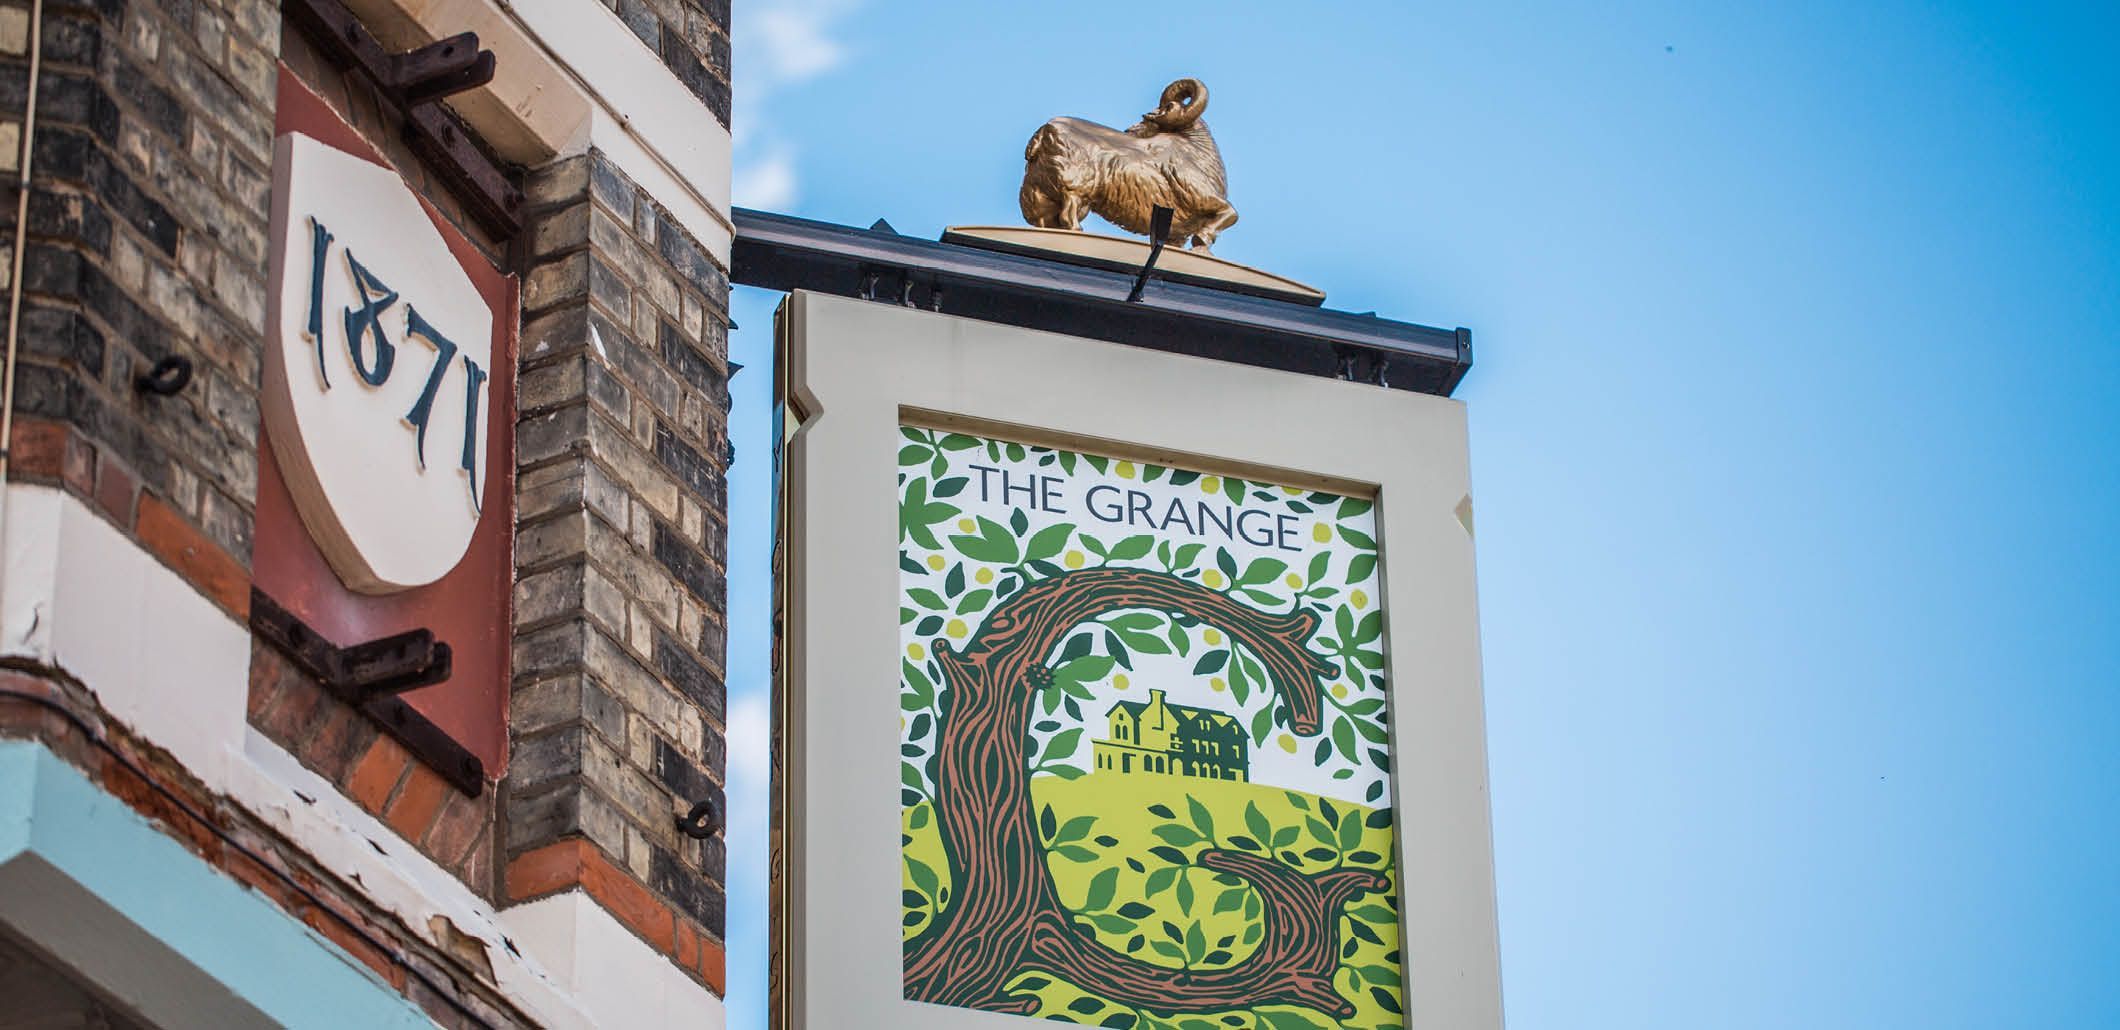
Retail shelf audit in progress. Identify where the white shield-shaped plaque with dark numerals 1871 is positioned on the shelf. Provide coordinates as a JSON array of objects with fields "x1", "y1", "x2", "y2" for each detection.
[{"x1": 261, "y1": 134, "x2": 494, "y2": 593}]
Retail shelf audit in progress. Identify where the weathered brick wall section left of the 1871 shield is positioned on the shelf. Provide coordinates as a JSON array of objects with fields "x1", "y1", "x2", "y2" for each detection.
[{"x1": 0, "y1": 0, "x2": 280, "y2": 615}]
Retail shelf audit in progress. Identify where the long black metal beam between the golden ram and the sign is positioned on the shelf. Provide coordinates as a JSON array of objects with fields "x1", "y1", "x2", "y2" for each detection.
[{"x1": 729, "y1": 208, "x2": 1471, "y2": 396}]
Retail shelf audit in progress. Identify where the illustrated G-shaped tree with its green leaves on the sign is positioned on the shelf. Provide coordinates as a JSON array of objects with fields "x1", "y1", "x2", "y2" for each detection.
[{"x1": 899, "y1": 428, "x2": 1397, "y2": 1026}]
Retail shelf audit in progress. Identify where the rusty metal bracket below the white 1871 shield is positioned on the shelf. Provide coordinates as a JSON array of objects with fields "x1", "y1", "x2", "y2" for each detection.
[{"x1": 250, "y1": 587, "x2": 485, "y2": 797}]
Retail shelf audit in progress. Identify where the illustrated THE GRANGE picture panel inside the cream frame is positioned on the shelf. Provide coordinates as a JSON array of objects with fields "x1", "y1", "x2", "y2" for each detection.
[{"x1": 897, "y1": 426, "x2": 1403, "y2": 1030}]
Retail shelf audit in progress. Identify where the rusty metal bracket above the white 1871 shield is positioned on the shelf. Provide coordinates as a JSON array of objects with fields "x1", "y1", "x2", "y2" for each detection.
[{"x1": 280, "y1": 0, "x2": 524, "y2": 239}]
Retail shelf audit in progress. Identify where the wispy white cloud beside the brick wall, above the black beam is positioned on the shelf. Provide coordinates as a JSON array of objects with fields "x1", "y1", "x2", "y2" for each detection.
[{"x1": 729, "y1": 0, "x2": 856, "y2": 210}]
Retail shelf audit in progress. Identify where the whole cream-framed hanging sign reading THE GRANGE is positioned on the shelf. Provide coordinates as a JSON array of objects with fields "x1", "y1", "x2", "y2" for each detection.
[{"x1": 776, "y1": 292, "x2": 1501, "y2": 1030}]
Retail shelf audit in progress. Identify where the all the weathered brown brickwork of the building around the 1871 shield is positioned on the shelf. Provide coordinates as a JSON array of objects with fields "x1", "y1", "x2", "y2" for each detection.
[{"x1": 0, "y1": 0, "x2": 746, "y2": 1004}]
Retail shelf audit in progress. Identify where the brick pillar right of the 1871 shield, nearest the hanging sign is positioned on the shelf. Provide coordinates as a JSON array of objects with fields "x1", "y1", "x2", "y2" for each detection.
[{"x1": 502, "y1": 150, "x2": 729, "y2": 992}]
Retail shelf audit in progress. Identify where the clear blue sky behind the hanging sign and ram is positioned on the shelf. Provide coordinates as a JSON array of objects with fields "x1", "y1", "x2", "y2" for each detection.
[{"x1": 729, "y1": 0, "x2": 2120, "y2": 1030}]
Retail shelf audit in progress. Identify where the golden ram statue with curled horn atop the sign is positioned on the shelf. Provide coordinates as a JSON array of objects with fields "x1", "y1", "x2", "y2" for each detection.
[{"x1": 1018, "y1": 78, "x2": 1236, "y2": 254}]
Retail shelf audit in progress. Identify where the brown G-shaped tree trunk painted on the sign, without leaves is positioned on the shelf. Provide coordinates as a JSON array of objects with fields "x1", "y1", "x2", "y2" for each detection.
[{"x1": 905, "y1": 568, "x2": 1386, "y2": 1017}]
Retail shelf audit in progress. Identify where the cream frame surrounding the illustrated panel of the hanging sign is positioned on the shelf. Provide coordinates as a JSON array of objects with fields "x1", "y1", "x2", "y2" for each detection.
[{"x1": 774, "y1": 292, "x2": 1501, "y2": 1030}]
